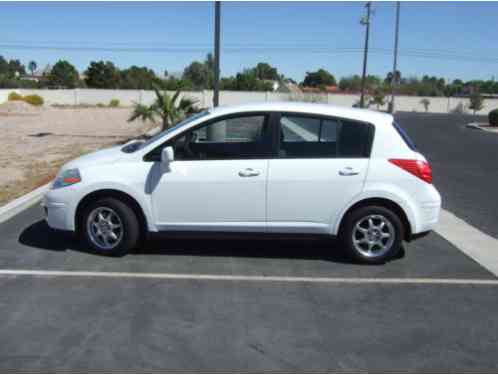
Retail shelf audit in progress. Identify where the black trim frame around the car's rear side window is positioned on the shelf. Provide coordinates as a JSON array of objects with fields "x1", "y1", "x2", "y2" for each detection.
[{"x1": 274, "y1": 111, "x2": 375, "y2": 160}]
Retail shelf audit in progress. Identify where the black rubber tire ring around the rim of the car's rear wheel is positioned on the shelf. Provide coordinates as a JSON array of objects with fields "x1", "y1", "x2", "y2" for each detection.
[{"x1": 340, "y1": 206, "x2": 404, "y2": 264}]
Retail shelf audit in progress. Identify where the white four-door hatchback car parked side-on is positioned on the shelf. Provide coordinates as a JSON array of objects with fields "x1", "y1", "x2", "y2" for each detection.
[{"x1": 43, "y1": 103, "x2": 441, "y2": 263}]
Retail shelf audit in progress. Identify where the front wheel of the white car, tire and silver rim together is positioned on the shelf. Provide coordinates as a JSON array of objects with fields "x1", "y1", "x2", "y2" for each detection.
[{"x1": 79, "y1": 198, "x2": 140, "y2": 256}]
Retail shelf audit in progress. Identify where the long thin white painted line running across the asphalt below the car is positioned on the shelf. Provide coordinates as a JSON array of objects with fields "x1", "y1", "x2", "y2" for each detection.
[{"x1": 0, "y1": 270, "x2": 498, "y2": 285}]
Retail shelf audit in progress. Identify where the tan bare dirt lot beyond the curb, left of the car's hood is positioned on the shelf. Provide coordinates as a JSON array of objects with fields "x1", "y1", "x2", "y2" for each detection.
[{"x1": 0, "y1": 107, "x2": 154, "y2": 206}]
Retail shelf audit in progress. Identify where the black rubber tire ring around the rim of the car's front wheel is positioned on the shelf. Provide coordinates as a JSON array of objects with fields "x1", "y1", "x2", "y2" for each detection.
[{"x1": 80, "y1": 198, "x2": 140, "y2": 256}]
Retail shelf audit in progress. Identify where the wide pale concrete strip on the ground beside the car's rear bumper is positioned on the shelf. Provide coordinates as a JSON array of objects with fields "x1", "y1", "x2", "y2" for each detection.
[{"x1": 436, "y1": 210, "x2": 498, "y2": 276}]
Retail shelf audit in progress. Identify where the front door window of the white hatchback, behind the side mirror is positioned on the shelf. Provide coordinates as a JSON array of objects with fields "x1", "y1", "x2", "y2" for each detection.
[{"x1": 173, "y1": 114, "x2": 270, "y2": 160}]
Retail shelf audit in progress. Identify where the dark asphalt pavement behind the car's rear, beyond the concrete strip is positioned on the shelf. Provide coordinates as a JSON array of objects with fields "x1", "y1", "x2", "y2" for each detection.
[{"x1": 396, "y1": 113, "x2": 498, "y2": 238}]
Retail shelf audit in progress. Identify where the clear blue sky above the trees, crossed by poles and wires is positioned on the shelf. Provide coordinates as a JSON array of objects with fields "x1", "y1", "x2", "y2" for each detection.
[{"x1": 0, "y1": 2, "x2": 498, "y2": 81}]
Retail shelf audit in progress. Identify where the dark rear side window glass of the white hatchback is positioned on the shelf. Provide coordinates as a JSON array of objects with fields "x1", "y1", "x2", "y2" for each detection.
[{"x1": 279, "y1": 114, "x2": 371, "y2": 159}]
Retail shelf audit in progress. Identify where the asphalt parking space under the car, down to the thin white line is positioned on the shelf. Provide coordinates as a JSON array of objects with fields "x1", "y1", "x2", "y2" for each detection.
[{"x1": 0, "y1": 207, "x2": 493, "y2": 279}]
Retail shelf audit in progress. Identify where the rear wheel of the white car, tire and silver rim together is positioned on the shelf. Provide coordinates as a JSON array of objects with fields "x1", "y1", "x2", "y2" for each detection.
[{"x1": 340, "y1": 206, "x2": 404, "y2": 264}]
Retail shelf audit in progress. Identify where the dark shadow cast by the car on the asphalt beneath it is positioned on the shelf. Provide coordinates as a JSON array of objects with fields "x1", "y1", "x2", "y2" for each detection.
[{"x1": 19, "y1": 220, "x2": 404, "y2": 264}]
